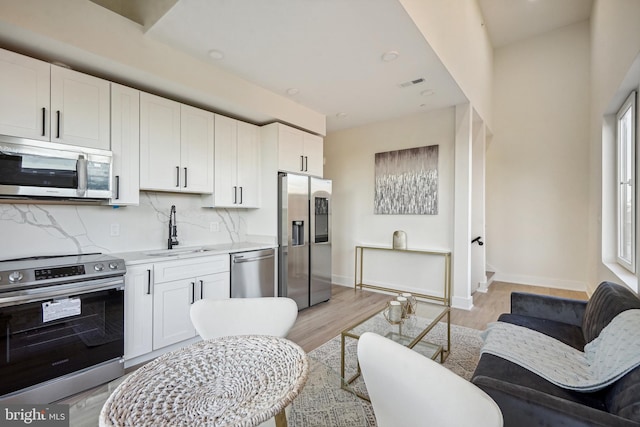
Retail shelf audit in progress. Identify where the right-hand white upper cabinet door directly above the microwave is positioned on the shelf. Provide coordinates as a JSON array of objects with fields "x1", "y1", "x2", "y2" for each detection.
[{"x1": 50, "y1": 65, "x2": 110, "y2": 150}]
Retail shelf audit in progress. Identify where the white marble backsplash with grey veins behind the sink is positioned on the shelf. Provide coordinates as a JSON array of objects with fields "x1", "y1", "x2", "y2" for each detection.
[{"x1": 0, "y1": 192, "x2": 266, "y2": 260}]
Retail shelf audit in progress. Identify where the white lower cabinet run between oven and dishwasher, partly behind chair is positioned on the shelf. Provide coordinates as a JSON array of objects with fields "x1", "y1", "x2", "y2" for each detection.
[{"x1": 125, "y1": 254, "x2": 231, "y2": 360}]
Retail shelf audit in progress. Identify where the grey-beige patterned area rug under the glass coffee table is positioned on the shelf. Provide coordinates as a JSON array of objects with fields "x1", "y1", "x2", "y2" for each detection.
[{"x1": 288, "y1": 323, "x2": 482, "y2": 427}]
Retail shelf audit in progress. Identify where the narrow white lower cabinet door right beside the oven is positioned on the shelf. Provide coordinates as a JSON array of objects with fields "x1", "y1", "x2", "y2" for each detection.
[{"x1": 124, "y1": 264, "x2": 153, "y2": 360}]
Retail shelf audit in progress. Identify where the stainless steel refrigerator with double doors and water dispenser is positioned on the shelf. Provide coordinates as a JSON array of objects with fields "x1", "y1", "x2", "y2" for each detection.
[{"x1": 278, "y1": 172, "x2": 331, "y2": 310}]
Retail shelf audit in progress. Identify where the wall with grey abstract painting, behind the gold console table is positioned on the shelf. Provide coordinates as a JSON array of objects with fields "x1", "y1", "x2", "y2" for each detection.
[{"x1": 324, "y1": 108, "x2": 455, "y2": 298}]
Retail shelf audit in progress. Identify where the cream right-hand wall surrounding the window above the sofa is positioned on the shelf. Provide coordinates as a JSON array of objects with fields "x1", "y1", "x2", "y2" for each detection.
[{"x1": 588, "y1": 0, "x2": 640, "y2": 291}]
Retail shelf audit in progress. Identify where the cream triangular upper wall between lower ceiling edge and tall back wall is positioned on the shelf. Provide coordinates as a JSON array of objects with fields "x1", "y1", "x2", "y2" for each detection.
[{"x1": 399, "y1": 0, "x2": 493, "y2": 128}]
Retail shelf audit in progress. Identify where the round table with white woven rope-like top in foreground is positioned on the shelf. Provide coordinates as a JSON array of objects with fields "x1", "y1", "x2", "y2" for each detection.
[{"x1": 100, "y1": 335, "x2": 309, "y2": 427}]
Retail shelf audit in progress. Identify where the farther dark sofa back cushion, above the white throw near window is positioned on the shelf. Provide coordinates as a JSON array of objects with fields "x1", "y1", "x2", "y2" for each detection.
[{"x1": 584, "y1": 282, "x2": 640, "y2": 343}]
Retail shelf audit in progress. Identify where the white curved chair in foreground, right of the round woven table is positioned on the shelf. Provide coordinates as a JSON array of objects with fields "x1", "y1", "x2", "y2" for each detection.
[{"x1": 358, "y1": 332, "x2": 503, "y2": 427}]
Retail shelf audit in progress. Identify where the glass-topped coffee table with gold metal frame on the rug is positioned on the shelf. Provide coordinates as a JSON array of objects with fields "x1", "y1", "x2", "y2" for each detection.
[{"x1": 340, "y1": 300, "x2": 451, "y2": 400}]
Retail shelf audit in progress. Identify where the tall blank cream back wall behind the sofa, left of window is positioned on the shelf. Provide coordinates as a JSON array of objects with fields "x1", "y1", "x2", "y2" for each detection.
[{"x1": 486, "y1": 22, "x2": 590, "y2": 290}]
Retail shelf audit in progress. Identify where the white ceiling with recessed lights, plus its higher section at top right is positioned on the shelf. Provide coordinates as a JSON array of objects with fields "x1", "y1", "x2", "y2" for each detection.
[{"x1": 112, "y1": 0, "x2": 592, "y2": 131}]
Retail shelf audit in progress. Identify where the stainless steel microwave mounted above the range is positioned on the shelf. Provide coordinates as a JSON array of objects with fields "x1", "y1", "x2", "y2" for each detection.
[{"x1": 0, "y1": 135, "x2": 113, "y2": 200}]
